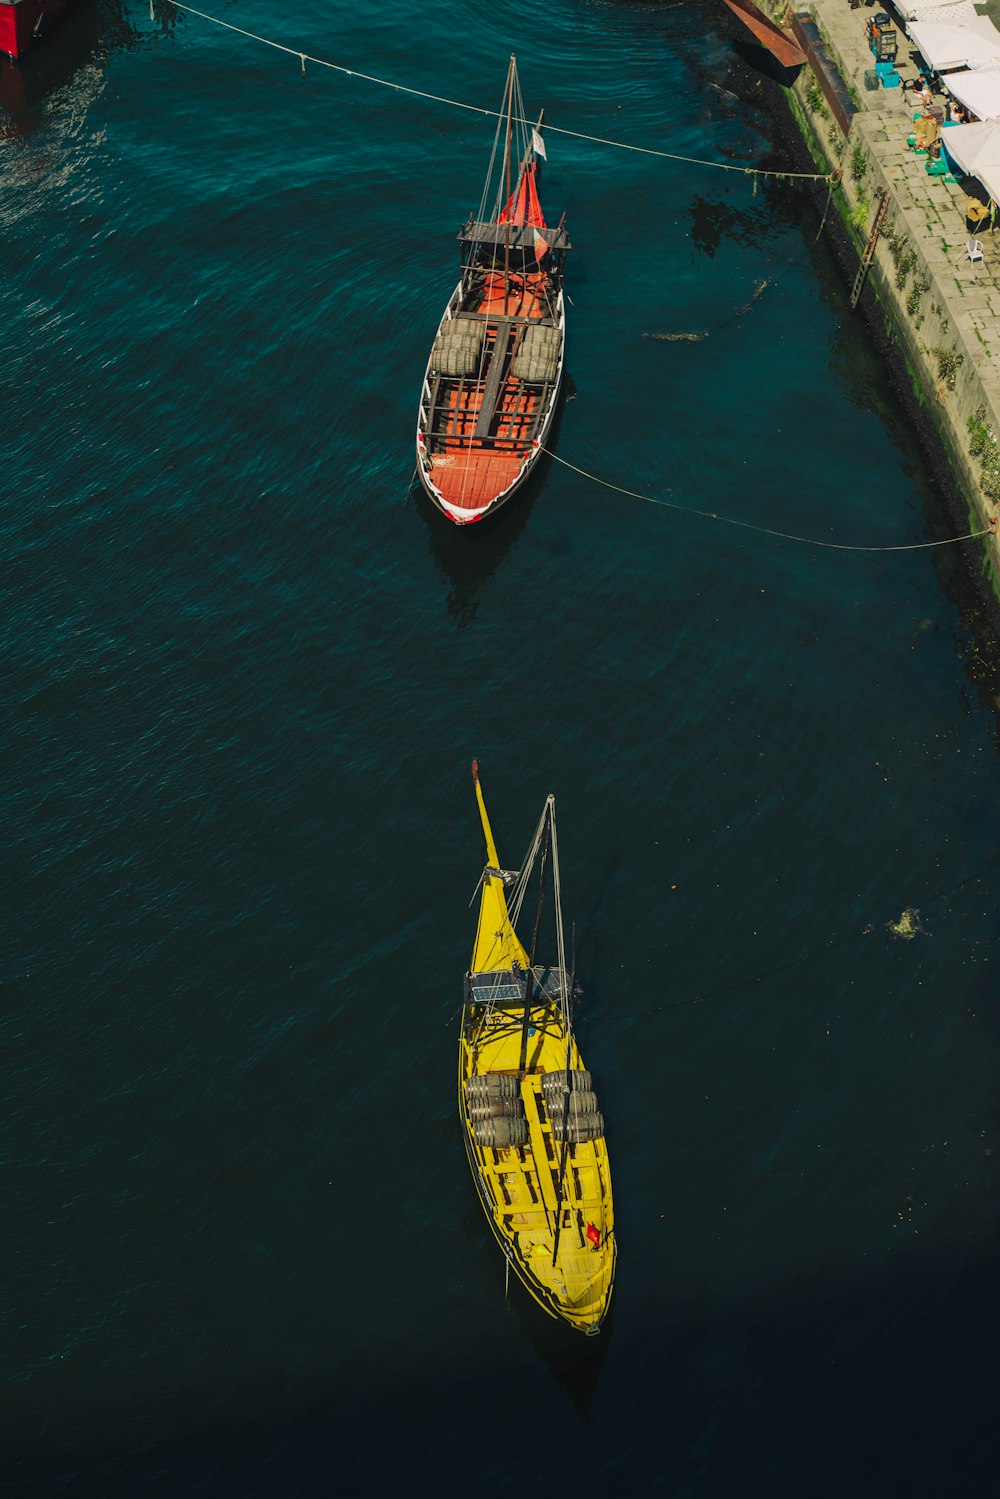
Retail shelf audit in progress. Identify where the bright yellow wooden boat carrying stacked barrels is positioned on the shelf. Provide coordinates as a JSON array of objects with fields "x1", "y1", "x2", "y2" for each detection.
[{"x1": 459, "y1": 760, "x2": 616, "y2": 1334}]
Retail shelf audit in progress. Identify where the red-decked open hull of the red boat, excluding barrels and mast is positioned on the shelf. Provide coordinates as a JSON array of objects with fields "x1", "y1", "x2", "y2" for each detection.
[{"x1": 417, "y1": 273, "x2": 565, "y2": 526}]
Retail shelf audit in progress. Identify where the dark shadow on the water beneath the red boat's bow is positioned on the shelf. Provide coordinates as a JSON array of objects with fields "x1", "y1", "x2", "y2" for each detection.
[{"x1": 408, "y1": 373, "x2": 576, "y2": 630}]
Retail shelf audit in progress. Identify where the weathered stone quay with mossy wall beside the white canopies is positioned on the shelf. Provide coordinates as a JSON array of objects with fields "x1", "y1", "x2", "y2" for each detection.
[{"x1": 765, "y1": 0, "x2": 1000, "y2": 601}]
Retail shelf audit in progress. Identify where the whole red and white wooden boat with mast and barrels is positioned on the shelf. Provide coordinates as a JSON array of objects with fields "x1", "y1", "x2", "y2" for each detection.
[{"x1": 417, "y1": 57, "x2": 570, "y2": 526}]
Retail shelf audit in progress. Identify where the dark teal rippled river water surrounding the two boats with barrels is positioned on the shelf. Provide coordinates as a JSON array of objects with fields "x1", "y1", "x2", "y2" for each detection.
[{"x1": 0, "y1": 0, "x2": 1000, "y2": 1499}]
